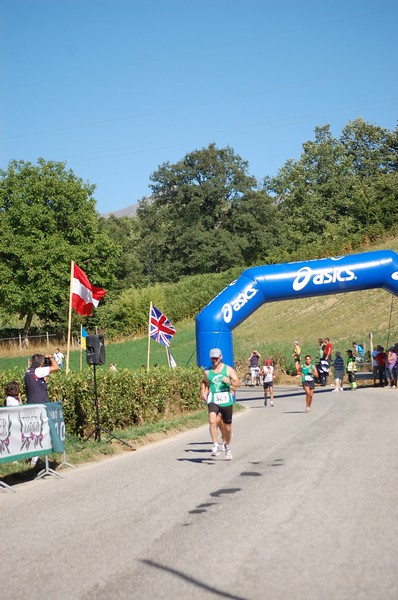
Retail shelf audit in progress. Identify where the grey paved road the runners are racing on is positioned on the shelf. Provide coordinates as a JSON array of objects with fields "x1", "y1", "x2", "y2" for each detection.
[{"x1": 0, "y1": 387, "x2": 398, "y2": 600}]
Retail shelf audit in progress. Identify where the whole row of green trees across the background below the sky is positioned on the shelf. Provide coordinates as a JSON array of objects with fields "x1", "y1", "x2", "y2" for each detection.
[{"x1": 0, "y1": 119, "x2": 398, "y2": 330}]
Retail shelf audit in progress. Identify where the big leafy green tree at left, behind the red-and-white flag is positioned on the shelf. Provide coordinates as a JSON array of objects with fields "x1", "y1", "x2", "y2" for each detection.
[{"x1": 0, "y1": 159, "x2": 119, "y2": 334}]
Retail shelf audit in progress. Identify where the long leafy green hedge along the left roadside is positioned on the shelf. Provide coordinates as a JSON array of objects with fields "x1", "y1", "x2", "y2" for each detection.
[{"x1": 0, "y1": 367, "x2": 203, "y2": 437}]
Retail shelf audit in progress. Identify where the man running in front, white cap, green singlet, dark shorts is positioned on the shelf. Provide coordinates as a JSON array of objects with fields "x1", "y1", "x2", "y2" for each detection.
[{"x1": 200, "y1": 348, "x2": 240, "y2": 460}]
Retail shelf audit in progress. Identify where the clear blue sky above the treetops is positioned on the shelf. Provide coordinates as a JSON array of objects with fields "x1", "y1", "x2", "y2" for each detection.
[{"x1": 0, "y1": 0, "x2": 398, "y2": 213}]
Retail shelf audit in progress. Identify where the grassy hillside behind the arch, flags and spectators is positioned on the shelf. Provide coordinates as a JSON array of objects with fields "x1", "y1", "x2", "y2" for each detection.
[{"x1": 0, "y1": 237, "x2": 398, "y2": 370}]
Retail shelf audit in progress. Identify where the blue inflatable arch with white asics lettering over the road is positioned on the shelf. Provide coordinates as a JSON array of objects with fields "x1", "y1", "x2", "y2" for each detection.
[{"x1": 196, "y1": 250, "x2": 398, "y2": 368}]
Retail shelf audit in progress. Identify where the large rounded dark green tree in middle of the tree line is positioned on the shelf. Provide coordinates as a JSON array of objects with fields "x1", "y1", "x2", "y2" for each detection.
[{"x1": 137, "y1": 144, "x2": 273, "y2": 282}]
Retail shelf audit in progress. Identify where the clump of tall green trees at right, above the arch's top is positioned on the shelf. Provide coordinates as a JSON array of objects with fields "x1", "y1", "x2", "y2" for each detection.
[{"x1": 265, "y1": 119, "x2": 398, "y2": 258}]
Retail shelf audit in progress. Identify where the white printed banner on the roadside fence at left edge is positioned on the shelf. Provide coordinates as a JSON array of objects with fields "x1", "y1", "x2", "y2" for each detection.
[{"x1": 0, "y1": 404, "x2": 52, "y2": 464}]
